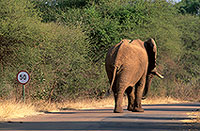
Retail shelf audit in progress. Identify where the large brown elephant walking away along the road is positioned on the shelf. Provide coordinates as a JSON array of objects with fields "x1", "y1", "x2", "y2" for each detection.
[{"x1": 105, "y1": 38, "x2": 163, "y2": 113}]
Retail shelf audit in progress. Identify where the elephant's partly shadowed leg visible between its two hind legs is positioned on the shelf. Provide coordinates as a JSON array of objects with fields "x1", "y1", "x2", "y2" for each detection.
[{"x1": 126, "y1": 86, "x2": 135, "y2": 111}]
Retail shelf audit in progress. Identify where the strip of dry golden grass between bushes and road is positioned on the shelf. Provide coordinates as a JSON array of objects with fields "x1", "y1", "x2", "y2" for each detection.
[{"x1": 0, "y1": 97, "x2": 190, "y2": 120}]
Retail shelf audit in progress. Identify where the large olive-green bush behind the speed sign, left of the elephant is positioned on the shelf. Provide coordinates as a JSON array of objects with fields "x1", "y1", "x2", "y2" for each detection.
[{"x1": 0, "y1": 0, "x2": 108, "y2": 100}]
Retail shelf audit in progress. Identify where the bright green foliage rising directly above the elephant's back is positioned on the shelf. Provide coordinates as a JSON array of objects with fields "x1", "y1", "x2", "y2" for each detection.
[{"x1": 58, "y1": 0, "x2": 183, "y2": 62}]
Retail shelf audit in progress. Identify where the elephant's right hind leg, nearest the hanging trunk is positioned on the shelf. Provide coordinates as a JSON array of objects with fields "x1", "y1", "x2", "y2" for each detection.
[{"x1": 133, "y1": 77, "x2": 146, "y2": 112}]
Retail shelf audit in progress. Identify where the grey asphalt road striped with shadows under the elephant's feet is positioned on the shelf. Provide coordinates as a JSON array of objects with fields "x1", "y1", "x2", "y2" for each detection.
[{"x1": 0, "y1": 103, "x2": 200, "y2": 131}]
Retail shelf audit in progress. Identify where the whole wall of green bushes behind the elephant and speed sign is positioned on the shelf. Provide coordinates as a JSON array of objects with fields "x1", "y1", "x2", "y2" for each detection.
[{"x1": 0, "y1": 0, "x2": 200, "y2": 116}]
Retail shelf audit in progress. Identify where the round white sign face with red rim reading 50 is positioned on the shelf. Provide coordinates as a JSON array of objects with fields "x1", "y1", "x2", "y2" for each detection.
[{"x1": 17, "y1": 71, "x2": 30, "y2": 85}]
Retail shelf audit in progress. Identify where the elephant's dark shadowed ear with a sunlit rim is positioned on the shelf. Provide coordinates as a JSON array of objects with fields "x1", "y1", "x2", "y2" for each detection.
[{"x1": 144, "y1": 38, "x2": 157, "y2": 72}]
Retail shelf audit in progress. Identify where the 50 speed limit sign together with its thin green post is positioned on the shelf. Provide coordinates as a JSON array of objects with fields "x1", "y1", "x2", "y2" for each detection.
[{"x1": 17, "y1": 70, "x2": 30, "y2": 102}]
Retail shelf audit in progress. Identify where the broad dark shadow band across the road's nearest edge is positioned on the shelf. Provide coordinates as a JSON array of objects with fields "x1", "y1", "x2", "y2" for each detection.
[{"x1": 0, "y1": 121, "x2": 199, "y2": 131}]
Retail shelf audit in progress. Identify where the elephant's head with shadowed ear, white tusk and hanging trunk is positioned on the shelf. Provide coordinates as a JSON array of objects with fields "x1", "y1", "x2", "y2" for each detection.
[{"x1": 143, "y1": 38, "x2": 164, "y2": 99}]
